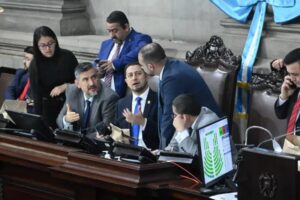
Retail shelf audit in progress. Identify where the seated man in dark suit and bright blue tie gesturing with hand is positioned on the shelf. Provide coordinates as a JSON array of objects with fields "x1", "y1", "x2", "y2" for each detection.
[{"x1": 115, "y1": 64, "x2": 159, "y2": 149}]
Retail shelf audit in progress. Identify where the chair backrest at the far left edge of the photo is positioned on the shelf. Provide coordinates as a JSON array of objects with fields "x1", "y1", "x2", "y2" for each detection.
[{"x1": 0, "y1": 67, "x2": 16, "y2": 105}]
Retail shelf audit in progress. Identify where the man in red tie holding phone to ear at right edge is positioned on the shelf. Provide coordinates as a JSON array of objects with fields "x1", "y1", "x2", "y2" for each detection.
[{"x1": 275, "y1": 48, "x2": 300, "y2": 135}]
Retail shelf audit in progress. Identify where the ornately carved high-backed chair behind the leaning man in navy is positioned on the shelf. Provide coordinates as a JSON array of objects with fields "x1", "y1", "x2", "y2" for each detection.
[{"x1": 186, "y1": 36, "x2": 241, "y2": 141}]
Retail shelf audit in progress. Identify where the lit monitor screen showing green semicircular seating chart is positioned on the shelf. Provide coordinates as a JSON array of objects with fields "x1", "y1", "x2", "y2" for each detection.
[{"x1": 197, "y1": 117, "x2": 233, "y2": 187}]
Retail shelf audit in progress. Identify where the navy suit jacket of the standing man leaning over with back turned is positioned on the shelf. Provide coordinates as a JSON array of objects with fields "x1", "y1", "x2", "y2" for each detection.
[{"x1": 158, "y1": 59, "x2": 221, "y2": 149}]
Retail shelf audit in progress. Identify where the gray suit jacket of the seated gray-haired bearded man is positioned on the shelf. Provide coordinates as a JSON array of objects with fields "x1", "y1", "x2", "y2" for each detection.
[{"x1": 56, "y1": 82, "x2": 119, "y2": 132}]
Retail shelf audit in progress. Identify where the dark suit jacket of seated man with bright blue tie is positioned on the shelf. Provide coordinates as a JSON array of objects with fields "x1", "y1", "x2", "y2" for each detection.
[{"x1": 115, "y1": 89, "x2": 159, "y2": 149}]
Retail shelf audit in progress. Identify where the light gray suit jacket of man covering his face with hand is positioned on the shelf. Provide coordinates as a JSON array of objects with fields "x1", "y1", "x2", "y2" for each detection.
[{"x1": 165, "y1": 107, "x2": 219, "y2": 155}]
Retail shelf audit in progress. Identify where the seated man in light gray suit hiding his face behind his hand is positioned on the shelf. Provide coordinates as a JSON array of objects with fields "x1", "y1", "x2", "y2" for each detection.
[{"x1": 165, "y1": 94, "x2": 219, "y2": 155}]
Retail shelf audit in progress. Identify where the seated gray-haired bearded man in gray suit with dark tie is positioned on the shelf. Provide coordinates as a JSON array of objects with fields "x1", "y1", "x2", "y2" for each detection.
[{"x1": 56, "y1": 62, "x2": 119, "y2": 134}]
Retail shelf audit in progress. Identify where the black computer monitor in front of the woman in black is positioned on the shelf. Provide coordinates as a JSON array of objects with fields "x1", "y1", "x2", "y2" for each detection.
[{"x1": 6, "y1": 110, "x2": 55, "y2": 142}]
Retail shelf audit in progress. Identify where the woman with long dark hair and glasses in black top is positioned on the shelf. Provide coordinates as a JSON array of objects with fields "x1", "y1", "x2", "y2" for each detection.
[{"x1": 29, "y1": 26, "x2": 78, "y2": 128}]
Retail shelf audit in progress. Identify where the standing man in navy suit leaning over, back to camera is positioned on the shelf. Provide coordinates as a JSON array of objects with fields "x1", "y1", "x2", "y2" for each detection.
[{"x1": 138, "y1": 43, "x2": 221, "y2": 149}]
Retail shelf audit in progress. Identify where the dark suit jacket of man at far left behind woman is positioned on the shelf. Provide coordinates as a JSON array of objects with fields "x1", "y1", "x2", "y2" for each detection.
[{"x1": 4, "y1": 69, "x2": 31, "y2": 100}]
